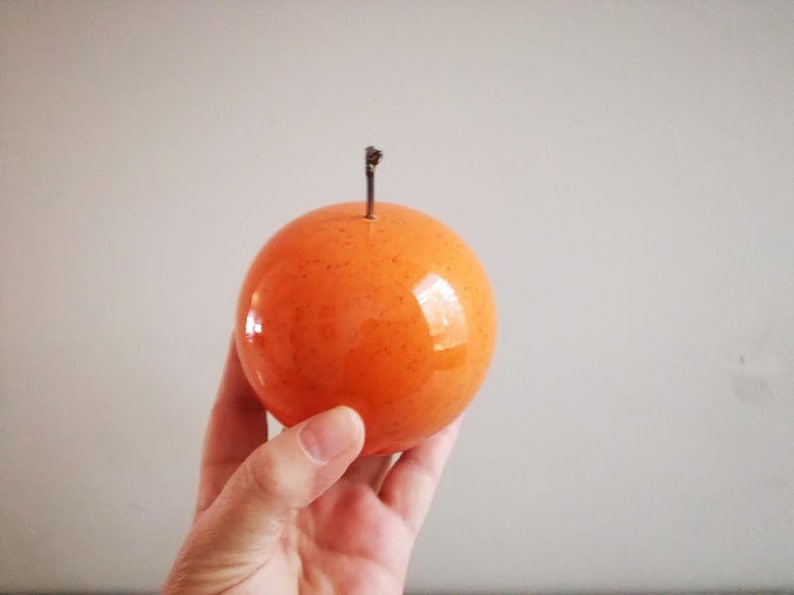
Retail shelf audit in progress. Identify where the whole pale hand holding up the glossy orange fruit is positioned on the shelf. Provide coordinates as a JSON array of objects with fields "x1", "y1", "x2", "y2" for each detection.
[{"x1": 163, "y1": 345, "x2": 460, "y2": 595}]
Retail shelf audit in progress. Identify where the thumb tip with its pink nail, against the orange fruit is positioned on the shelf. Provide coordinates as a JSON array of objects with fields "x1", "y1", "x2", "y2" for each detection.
[{"x1": 299, "y1": 407, "x2": 361, "y2": 463}]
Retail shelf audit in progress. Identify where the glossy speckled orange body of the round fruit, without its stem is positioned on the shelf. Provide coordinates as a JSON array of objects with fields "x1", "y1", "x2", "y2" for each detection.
[{"x1": 235, "y1": 202, "x2": 496, "y2": 454}]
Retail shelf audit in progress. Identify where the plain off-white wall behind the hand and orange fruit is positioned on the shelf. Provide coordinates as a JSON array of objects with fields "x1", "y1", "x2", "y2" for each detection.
[{"x1": 0, "y1": 1, "x2": 794, "y2": 592}]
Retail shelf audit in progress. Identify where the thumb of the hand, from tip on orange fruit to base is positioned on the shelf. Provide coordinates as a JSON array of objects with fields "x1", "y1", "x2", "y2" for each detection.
[{"x1": 166, "y1": 407, "x2": 364, "y2": 593}]
